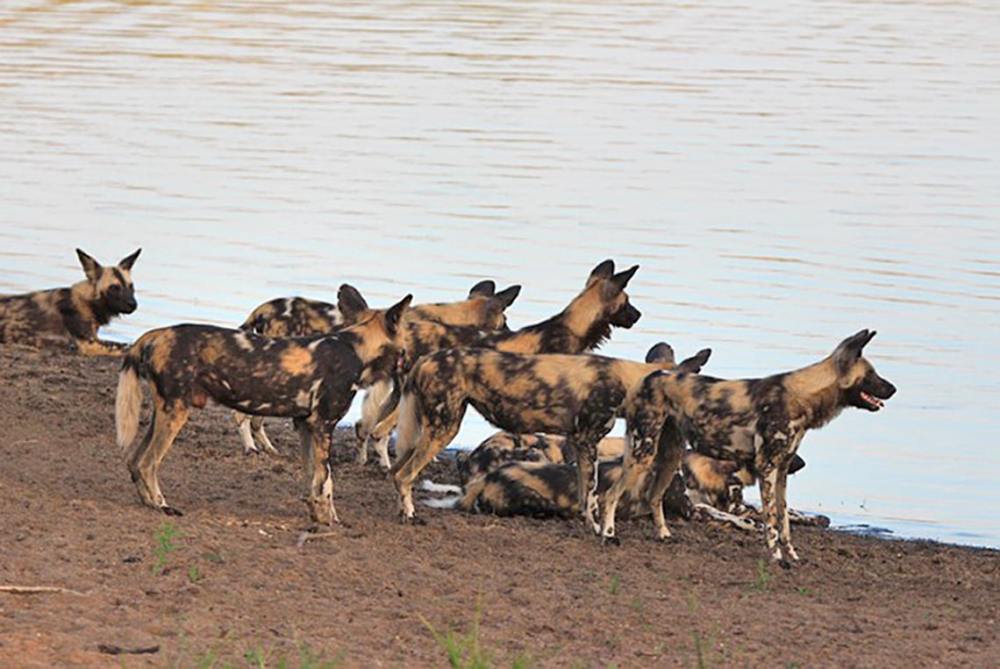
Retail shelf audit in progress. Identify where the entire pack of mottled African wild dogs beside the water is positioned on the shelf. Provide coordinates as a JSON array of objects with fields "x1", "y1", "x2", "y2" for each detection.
[{"x1": 0, "y1": 250, "x2": 896, "y2": 565}]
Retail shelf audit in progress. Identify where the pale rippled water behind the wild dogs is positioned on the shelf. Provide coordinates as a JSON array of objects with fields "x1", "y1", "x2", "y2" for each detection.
[{"x1": 0, "y1": 0, "x2": 1000, "y2": 546}]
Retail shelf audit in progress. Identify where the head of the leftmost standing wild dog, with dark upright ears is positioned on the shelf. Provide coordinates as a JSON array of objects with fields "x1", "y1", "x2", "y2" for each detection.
[{"x1": 342, "y1": 295, "x2": 413, "y2": 387}]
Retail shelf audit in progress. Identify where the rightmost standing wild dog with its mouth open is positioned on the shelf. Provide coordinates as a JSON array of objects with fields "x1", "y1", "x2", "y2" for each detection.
[{"x1": 601, "y1": 330, "x2": 896, "y2": 566}]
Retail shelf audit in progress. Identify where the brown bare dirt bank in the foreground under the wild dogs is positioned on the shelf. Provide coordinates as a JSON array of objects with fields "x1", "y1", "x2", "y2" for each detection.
[{"x1": 0, "y1": 346, "x2": 1000, "y2": 667}]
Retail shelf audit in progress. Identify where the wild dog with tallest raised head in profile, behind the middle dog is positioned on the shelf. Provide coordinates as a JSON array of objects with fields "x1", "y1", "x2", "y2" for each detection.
[{"x1": 357, "y1": 260, "x2": 641, "y2": 467}]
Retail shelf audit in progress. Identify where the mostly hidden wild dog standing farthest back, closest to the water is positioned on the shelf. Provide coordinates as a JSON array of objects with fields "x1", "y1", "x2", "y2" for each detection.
[{"x1": 234, "y1": 281, "x2": 521, "y2": 456}]
